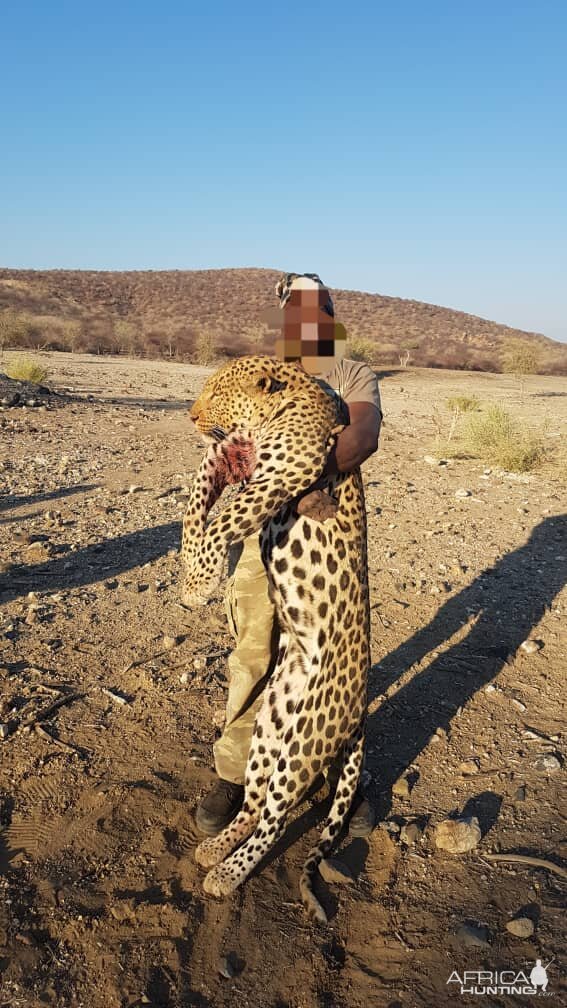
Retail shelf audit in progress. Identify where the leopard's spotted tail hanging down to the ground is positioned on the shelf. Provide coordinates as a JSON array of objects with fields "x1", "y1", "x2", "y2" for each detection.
[{"x1": 300, "y1": 725, "x2": 364, "y2": 923}]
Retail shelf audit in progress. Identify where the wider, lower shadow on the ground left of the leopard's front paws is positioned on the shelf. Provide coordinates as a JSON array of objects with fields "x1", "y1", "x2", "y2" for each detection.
[{"x1": 0, "y1": 521, "x2": 181, "y2": 605}]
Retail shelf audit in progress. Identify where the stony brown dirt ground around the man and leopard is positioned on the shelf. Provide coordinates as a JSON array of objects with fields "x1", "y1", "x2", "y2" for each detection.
[{"x1": 0, "y1": 354, "x2": 567, "y2": 1008}]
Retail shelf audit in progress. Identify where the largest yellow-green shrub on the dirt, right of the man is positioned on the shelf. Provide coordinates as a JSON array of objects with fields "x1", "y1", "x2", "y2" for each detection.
[{"x1": 463, "y1": 406, "x2": 544, "y2": 473}]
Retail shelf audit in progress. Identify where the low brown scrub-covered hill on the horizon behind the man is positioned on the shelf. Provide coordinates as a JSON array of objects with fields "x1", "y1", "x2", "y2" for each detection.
[{"x1": 0, "y1": 269, "x2": 567, "y2": 374}]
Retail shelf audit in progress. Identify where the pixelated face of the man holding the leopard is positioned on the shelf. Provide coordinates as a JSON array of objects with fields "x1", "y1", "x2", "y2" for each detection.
[{"x1": 264, "y1": 288, "x2": 346, "y2": 378}]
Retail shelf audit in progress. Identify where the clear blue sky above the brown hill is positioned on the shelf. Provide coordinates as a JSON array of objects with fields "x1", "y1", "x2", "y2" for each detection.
[{"x1": 0, "y1": 0, "x2": 567, "y2": 340}]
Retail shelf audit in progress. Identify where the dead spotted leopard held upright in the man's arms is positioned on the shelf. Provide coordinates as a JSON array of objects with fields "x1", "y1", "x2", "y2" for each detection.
[{"x1": 181, "y1": 355, "x2": 370, "y2": 922}]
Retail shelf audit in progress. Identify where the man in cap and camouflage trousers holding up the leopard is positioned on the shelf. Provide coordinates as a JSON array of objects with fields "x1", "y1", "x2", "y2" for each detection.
[{"x1": 193, "y1": 273, "x2": 381, "y2": 837}]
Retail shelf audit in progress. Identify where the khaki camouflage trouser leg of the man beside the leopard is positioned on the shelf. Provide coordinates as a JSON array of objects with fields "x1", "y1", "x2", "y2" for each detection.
[{"x1": 213, "y1": 533, "x2": 278, "y2": 784}]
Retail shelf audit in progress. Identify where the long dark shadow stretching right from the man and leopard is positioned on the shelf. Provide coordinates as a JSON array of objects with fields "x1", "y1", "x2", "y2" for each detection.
[{"x1": 366, "y1": 515, "x2": 567, "y2": 818}]
